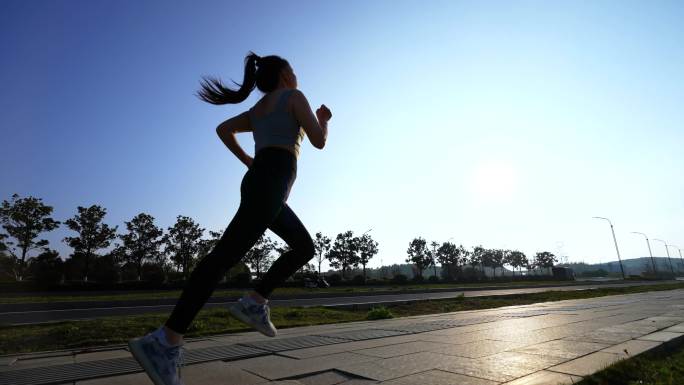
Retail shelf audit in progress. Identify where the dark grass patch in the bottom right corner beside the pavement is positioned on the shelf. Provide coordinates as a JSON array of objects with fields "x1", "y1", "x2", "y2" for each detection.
[{"x1": 577, "y1": 338, "x2": 684, "y2": 385}]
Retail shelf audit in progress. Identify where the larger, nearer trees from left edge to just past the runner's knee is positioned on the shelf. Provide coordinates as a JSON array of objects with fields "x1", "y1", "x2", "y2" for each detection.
[{"x1": 0, "y1": 194, "x2": 378, "y2": 281}]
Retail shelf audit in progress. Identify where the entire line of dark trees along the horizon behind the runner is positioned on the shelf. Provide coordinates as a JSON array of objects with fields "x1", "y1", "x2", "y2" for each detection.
[{"x1": 0, "y1": 194, "x2": 557, "y2": 283}]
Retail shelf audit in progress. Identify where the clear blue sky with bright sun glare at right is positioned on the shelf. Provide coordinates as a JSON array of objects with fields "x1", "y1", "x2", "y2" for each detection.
[{"x1": 0, "y1": 0, "x2": 684, "y2": 266}]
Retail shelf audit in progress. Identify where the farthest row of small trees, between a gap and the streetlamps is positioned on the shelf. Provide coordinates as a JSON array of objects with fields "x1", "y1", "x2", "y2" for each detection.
[{"x1": 406, "y1": 237, "x2": 558, "y2": 278}]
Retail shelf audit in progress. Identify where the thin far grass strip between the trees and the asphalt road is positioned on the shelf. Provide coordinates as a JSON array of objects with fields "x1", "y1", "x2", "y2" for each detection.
[{"x1": 0, "y1": 281, "x2": 591, "y2": 304}]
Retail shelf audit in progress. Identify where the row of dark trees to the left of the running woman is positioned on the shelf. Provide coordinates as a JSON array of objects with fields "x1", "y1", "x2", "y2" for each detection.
[{"x1": 0, "y1": 194, "x2": 272, "y2": 281}]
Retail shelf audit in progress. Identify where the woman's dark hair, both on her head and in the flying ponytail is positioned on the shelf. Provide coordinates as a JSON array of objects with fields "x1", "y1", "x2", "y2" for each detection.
[{"x1": 197, "y1": 51, "x2": 290, "y2": 104}]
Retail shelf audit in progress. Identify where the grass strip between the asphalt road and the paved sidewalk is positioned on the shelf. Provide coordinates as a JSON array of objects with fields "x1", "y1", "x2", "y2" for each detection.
[{"x1": 0, "y1": 283, "x2": 684, "y2": 354}]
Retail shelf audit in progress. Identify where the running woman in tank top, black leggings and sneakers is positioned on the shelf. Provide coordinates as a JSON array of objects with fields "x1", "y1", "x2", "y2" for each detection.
[{"x1": 128, "y1": 53, "x2": 332, "y2": 385}]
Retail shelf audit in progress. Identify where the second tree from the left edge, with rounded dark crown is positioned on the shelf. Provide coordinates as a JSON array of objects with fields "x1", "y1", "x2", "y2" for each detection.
[{"x1": 64, "y1": 205, "x2": 118, "y2": 282}]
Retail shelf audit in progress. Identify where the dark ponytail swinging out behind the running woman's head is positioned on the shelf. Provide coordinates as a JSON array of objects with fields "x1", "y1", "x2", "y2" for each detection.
[{"x1": 197, "y1": 52, "x2": 259, "y2": 105}]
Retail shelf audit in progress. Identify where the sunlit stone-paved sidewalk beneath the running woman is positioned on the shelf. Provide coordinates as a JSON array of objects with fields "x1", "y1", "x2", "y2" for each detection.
[{"x1": 0, "y1": 290, "x2": 684, "y2": 385}]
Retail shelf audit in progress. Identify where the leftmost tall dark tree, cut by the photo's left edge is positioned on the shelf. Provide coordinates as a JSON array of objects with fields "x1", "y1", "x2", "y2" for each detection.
[{"x1": 0, "y1": 194, "x2": 59, "y2": 281}]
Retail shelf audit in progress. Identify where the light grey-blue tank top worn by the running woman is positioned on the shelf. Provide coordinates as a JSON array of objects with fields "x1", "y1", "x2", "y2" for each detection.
[{"x1": 249, "y1": 90, "x2": 304, "y2": 157}]
